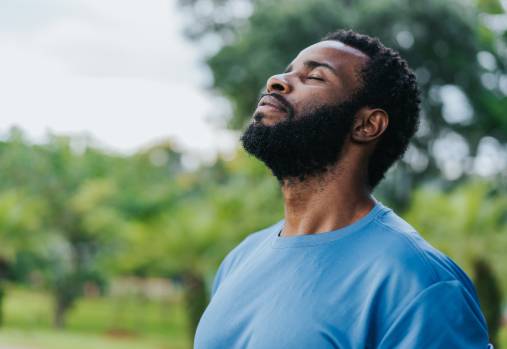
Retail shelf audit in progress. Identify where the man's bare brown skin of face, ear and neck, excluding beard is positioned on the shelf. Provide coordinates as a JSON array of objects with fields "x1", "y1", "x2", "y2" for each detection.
[{"x1": 256, "y1": 41, "x2": 389, "y2": 236}]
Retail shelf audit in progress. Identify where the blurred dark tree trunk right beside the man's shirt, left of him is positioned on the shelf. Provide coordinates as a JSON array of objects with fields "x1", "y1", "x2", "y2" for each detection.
[{"x1": 183, "y1": 270, "x2": 208, "y2": 345}]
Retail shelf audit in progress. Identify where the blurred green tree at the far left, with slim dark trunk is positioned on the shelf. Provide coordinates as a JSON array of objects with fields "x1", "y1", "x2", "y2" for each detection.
[{"x1": 0, "y1": 130, "x2": 183, "y2": 326}]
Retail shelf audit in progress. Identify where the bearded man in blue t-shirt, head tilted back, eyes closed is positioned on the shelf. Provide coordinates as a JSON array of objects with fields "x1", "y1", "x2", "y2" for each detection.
[{"x1": 194, "y1": 31, "x2": 492, "y2": 349}]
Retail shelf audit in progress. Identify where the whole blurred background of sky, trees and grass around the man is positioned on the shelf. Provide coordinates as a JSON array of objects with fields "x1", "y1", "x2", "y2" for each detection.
[{"x1": 0, "y1": 0, "x2": 507, "y2": 349}]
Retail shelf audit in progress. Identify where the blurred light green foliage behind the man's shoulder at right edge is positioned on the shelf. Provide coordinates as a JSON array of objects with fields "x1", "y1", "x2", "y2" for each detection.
[{"x1": 404, "y1": 180, "x2": 507, "y2": 298}]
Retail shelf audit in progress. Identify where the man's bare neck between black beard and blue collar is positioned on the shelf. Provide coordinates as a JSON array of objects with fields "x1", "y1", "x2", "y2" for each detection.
[{"x1": 280, "y1": 155, "x2": 374, "y2": 236}]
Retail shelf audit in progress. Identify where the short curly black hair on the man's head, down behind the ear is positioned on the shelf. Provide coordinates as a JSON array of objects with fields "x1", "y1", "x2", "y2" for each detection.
[{"x1": 321, "y1": 30, "x2": 421, "y2": 189}]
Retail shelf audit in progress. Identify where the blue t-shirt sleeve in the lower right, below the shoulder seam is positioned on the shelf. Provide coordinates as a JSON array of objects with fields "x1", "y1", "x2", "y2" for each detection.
[{"x1": 377, "y1": 280, "x2": 493, "y2": 349}]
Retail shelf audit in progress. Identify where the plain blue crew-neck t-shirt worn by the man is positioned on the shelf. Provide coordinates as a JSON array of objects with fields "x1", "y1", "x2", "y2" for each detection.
[{"x1": 194, "y1": 201, "x2": 492, "y2": 349}]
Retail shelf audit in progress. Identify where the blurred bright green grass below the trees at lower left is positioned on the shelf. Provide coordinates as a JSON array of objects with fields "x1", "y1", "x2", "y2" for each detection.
[{"x1": 0, "y1": 287, "x2": 190, "y2": 349}]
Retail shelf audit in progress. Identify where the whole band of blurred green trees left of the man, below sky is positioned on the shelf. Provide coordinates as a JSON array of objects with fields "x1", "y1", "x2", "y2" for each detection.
[{"x1": 0, "y1": 131, "x2": 281, "y2": 338}]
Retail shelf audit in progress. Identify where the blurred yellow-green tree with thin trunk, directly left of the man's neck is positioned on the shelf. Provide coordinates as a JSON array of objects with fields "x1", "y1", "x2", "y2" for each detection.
[{"x1": 113, "y1": 147, "x2": 282, "y2": 340}]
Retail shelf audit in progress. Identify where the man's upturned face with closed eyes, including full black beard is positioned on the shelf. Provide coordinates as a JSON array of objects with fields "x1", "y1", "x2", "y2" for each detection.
[{"x1": 241, "y1": 41, "x2": 368, "y2": 181}]
